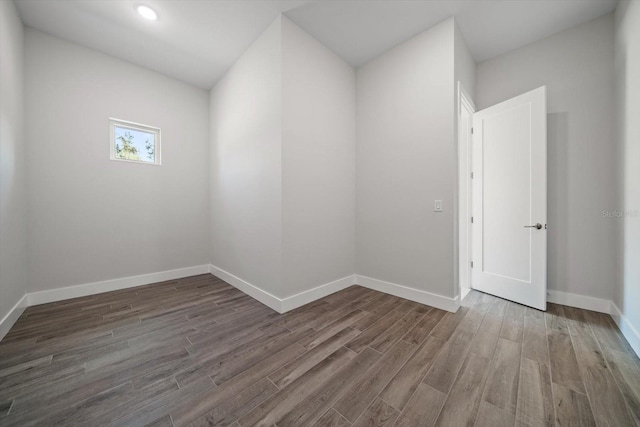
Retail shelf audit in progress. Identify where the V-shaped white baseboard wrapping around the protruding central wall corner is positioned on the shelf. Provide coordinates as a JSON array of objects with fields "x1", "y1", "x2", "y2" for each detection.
[{"x1": 210, "y1": 265, "x2": 355, "y2": 313}]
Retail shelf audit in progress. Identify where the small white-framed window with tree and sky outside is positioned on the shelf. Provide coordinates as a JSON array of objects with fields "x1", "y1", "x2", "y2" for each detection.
[{"x1": 109, "y1": 119, "x2": 160, "y2": 165}]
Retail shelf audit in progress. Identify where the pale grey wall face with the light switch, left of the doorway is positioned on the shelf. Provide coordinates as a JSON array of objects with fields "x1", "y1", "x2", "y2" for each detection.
[{"x1": 356, "y1": 19, "x2": 457, "y2": 298}]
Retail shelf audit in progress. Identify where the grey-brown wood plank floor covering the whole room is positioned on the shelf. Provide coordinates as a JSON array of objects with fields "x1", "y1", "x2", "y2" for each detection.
[{"x1": 0, "y1": 275, "x2": 640, "y2": 427}]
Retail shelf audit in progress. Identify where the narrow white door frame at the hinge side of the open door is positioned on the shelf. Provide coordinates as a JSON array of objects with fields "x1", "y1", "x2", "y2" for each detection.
[{"x1": 456, "y1": 81, "x2": 476, "y2": 301}]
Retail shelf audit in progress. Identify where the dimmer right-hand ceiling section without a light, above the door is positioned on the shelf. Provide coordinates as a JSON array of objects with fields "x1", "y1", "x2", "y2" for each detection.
[{"x1": 286, "y1": 0, "x2": 617, "y2": 67}]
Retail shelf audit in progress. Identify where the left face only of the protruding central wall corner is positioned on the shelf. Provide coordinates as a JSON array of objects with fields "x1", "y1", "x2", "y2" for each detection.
[{"x1": 210, "y1": 18, "x2": 282, "y2": 297}]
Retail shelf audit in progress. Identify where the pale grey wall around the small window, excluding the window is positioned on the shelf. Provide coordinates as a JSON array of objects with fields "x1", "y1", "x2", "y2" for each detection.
[{"x1": 25, "y1": 29, "x2": 209, "y2": 291}]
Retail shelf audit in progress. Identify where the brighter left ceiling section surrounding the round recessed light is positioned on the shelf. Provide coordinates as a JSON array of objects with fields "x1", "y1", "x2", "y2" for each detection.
[{"x1": 13, "y1": 0, "x2": 303, "y2": 88}]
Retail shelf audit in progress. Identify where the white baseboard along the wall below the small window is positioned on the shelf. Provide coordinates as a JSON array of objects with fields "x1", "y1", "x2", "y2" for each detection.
[{"x1": 27, "y1": 264, "x2": 209, "y2": 306}]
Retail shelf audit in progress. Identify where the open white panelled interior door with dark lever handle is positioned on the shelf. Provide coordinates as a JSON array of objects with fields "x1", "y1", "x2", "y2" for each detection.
[{"x1": 471, "y1": 86, "x2": 547, "y2": 310}]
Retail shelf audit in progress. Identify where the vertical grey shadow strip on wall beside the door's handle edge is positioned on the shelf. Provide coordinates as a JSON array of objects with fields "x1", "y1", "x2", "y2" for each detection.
[{"x1": 547, "y1": 112, "x2": 570, "y2": 291}]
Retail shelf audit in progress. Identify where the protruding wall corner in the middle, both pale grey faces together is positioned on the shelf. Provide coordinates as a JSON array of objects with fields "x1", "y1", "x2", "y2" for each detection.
[{"x1": 211, "y1": 16, "x2": 355, "y2": 299}]
